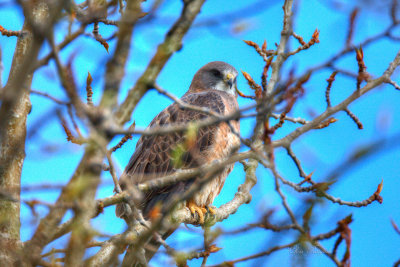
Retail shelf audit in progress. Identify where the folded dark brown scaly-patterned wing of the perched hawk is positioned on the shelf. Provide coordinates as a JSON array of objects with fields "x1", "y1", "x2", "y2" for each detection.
[{"x1": 117, "y1": 91, "x2": 233, "y2": 216}]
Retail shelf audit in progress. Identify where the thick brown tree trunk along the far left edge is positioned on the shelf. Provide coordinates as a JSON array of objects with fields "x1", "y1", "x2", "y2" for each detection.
[{"x1": 0, "y1": 2, "x2": 48, "y2": 266}]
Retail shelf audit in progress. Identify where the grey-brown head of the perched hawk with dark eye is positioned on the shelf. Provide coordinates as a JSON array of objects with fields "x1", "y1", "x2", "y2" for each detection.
[{"x1": 189, "y1": 61, "x2": 238, "y2": 96}]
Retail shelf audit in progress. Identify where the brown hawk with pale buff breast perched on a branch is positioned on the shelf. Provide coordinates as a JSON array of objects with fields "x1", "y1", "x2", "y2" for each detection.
[{"x1": 116, "y1": 61, "x2": 240, "y2": 266}]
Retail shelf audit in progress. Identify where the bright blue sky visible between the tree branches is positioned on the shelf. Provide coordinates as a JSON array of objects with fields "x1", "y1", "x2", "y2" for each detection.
[{"x1": 0, "y1": 0, "x2": 400, "y2": 266}]
